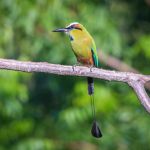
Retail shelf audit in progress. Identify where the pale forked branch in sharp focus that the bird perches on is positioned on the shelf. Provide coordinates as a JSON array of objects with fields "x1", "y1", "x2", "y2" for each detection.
[{"x1": 0, "y1": 59, "x2": 150, "y2": 113}]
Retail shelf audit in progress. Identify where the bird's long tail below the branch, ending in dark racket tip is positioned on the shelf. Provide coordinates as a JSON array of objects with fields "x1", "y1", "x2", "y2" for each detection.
[{"x1": 87, "y1": 77, "x2": 102, "y2": 138}]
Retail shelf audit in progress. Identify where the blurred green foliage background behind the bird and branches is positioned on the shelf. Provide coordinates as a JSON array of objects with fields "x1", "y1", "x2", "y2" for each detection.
[{"x1": 0, "y1": 0, "x2": 150, "y2": 150}]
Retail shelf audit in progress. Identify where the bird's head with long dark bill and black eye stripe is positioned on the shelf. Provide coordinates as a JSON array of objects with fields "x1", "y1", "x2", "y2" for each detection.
[{"x1": 53, "y1": 22, "x2": 84, "y2": 33}]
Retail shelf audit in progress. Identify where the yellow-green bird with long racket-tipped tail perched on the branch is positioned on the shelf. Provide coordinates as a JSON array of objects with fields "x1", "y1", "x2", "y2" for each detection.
[{"x1": 53, "y1": 22, "x2": 102, "y2": 138}]
